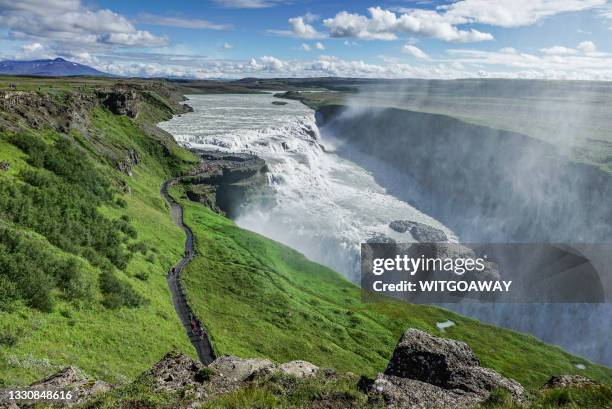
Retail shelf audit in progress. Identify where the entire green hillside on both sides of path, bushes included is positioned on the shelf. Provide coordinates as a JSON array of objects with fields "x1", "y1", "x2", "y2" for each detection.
[{"x1": 0, "y1": 74, "x2": 612, "y2": 392}]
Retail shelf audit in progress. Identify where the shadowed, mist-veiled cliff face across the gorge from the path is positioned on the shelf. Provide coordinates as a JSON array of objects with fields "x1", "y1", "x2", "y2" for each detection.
[{"x1": 317, "y1": 105, "x2": 612, "y2": 243}]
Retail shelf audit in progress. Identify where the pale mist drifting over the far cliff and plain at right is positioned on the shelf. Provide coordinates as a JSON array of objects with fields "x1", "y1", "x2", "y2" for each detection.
[{"x1": 318, "y1": 80, "x2": 612, "y2": 365}]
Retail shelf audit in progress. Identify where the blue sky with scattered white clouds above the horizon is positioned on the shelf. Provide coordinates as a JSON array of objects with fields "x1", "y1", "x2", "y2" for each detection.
[{"x1": 0, "y1": 0, "x2": 612, "y2": 80}]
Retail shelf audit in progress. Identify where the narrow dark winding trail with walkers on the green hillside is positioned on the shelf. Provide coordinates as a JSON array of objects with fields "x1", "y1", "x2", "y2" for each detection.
[{"x1": 160, "y1": 179, "x2": 215, "y2": 365}]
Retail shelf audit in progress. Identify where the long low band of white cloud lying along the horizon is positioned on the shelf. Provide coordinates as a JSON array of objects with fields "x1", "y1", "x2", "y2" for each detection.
[{"x1": 64, "y1": 49, "x2": 612, "y2": 81}]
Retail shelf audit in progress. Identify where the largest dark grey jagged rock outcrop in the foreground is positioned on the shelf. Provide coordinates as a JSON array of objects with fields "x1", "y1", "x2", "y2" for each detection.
[{"x1": 370, "y1": 328, "x2": 524, "y2": 408}]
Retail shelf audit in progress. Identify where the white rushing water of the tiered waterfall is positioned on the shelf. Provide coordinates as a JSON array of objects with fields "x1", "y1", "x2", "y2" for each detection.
[{"x1": 160, "y1": 94, "x2": 454, "y2": 281}]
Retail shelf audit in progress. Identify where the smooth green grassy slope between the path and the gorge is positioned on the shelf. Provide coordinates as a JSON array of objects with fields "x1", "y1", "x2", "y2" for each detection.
[{"x1": 173, "y1": 187, "x2": 612, "y2": 387}]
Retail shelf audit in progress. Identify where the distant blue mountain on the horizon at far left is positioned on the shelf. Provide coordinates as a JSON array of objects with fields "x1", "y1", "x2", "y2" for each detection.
[{"x1": 0, "y1": 58, "x2": 110, "y2": 77}]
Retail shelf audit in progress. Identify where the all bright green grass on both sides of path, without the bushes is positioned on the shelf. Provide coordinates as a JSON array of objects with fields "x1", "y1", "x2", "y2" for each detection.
[{"x1": 0, "y1": 78, "x2": 612, "y2": 396}]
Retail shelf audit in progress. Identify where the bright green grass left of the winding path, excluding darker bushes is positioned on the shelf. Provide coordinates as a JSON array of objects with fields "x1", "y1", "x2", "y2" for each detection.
[{"x1": 0, "y1": 80, "x2": 195, "y2": 386}]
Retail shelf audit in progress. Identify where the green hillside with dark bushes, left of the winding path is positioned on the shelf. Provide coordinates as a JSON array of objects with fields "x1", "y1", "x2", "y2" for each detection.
[{"x1": 0, "y1": 81, "x2": 193, "y2": 385}]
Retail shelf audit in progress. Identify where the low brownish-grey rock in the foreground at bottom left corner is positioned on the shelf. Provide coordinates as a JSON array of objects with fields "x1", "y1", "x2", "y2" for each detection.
[{"x1": 28, "y1": 366, "x2": 112, "y2": 406}]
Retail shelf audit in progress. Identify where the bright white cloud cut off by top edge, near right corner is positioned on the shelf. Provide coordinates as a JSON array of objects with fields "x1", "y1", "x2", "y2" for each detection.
[{"x1": 439, "y1": 0, "x2": 606, "y2": 27}]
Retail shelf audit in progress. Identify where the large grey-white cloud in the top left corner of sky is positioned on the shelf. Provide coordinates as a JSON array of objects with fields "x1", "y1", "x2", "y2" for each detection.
[{"x1": 0, "y1": 0, "x2": 168, "y2": 49}]
